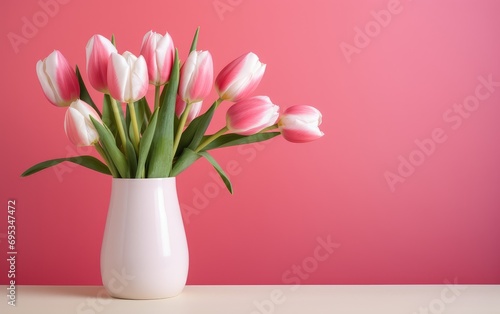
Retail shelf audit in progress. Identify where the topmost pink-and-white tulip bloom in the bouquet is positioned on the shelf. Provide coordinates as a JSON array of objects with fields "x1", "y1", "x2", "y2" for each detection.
[{"x1": 141, "y1": 31, "x2": 175, "y2": 85}]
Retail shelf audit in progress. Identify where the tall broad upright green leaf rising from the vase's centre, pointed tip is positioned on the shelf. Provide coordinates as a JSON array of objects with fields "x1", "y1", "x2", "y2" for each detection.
[{"x1": 148, "y1": 50, "x2": 180, "y2": 178}]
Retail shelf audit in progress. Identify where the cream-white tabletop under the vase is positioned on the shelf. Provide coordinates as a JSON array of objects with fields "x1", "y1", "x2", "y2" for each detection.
[{"x1": 0, "y1": 285, "x2": 500, "y2": 314}]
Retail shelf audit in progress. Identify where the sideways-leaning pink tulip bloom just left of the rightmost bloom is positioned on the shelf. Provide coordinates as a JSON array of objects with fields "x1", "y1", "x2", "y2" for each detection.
[{"x1": 226, "y1": 96, "x2": 279, "y2": 135}]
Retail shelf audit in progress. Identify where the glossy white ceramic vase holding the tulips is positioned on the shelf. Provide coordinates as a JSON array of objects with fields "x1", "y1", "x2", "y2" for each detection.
[{"x1": 101, "y1": 177, "x2": 189, "y2": 299}]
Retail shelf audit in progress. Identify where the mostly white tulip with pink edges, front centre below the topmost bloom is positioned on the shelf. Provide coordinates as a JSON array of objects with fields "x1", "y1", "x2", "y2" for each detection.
[{"x1": 108, "y1": 51, "x2": 148, "y2": 103}]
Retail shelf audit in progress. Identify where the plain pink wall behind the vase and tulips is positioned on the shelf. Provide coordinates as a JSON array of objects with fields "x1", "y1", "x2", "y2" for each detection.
[{"x1": 0, "y1": 0, "x2": 500, "y2": 285}]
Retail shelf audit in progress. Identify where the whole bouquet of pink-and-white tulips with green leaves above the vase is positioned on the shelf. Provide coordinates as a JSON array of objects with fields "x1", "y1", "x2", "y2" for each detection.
[{"x1": 22, "y1": 29, "x2": 323, "y2": 192}]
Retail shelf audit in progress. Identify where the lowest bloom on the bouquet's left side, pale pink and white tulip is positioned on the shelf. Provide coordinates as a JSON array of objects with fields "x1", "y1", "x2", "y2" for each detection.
[{"x1": 64, "y1": 99, "x2": 102, "y2": 146}]
